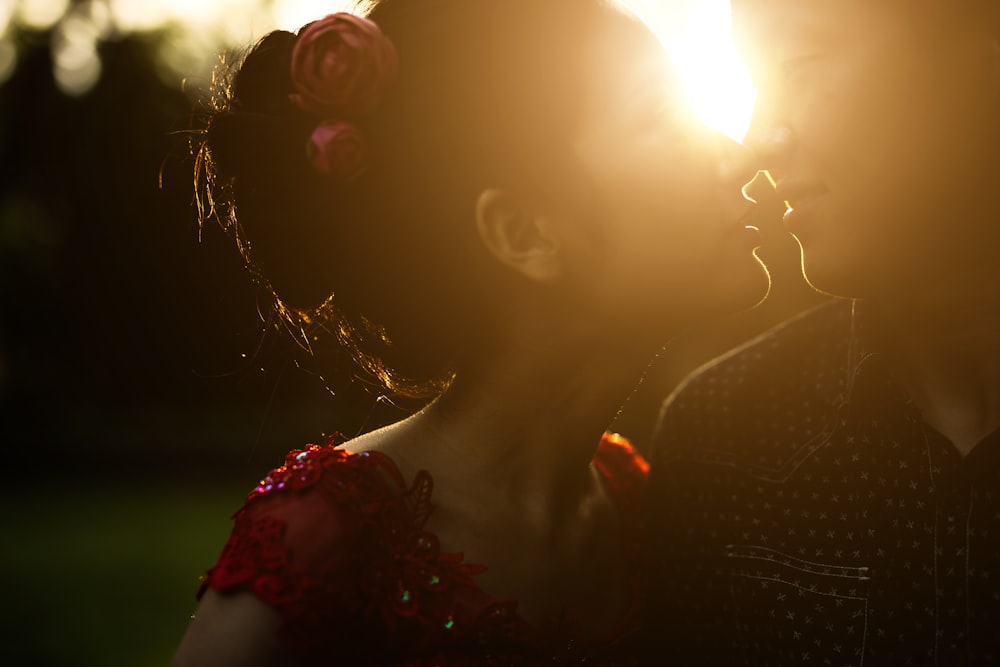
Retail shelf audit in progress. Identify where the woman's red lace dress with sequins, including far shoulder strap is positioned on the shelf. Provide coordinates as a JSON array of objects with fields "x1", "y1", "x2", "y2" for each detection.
[{"x1": 199, "y1": 434, "x2": 648, "y2": 667}]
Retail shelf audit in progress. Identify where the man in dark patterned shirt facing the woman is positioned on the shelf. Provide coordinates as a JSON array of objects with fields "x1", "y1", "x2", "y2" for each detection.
[{"x1": 646, "y1": 0, "x2": 1000, "y2": 667}]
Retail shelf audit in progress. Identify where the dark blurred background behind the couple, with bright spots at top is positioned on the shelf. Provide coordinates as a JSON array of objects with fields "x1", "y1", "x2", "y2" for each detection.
[{"x1": 0, "y1": 0, "x2": 816, "y2": 667}]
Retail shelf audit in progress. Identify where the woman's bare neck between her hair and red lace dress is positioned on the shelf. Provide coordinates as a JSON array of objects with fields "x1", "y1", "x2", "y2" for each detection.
[{"x1": 360, "y1": 310, "x2": 657, "y2": 523}]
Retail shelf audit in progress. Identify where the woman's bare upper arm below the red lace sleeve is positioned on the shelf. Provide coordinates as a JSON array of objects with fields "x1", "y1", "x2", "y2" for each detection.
[{"x1": 170, "y1": 590, "x2": 295, "y2": 667}]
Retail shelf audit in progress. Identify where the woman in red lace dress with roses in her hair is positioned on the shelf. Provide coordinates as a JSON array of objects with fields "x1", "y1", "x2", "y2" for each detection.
[{"x1": 173, "y1": 0, "x2": 767, "y2": 667}]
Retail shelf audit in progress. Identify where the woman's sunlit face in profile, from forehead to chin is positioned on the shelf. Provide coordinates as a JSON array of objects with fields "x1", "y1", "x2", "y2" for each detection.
[{"x1": 574, "y1": 15, "x2": 768, "y2": 330}]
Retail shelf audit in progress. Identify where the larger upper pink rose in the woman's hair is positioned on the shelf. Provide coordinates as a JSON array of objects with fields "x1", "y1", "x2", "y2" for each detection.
[{"x1": 291, "y1": 12, "x2": 398, "y2": 118}]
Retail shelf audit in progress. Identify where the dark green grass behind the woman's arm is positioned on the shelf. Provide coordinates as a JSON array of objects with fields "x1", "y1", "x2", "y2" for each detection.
[{"x1": 0, "y1": 481, "x2": 249, "y2": 667}]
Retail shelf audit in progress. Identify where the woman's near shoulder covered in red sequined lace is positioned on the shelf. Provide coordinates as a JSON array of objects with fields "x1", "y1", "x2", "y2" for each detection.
[{"x1": 199, "y1": 438, "x2": 482, "y2": 653}]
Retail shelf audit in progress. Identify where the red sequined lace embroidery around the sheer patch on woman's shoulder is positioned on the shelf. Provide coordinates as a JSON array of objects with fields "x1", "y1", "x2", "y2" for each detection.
[{"x1": 202, "y1": 439, "x2": 486, "y2": 650}]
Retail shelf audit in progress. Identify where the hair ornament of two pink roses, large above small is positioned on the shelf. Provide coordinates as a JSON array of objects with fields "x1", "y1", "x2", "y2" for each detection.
[{"x1": 289, "y1": 12, "x2": 398, "y2": 181}]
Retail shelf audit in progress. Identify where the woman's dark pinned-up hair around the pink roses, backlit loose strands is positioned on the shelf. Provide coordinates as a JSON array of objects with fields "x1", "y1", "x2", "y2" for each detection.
[{"x1": 194, "y1": 0, "x2": 613, "y2": 396}]
